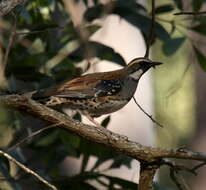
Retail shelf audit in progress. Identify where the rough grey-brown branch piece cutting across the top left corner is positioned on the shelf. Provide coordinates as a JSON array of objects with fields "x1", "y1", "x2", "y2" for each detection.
[{"x1": 0, "y1": 0, "x2": 26, "y2": 16}]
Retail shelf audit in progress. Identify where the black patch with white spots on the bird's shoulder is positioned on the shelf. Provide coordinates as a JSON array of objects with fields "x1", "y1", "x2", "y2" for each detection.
[{"x1": 95, "y1": 79, "x2": 122, "y2": 97}]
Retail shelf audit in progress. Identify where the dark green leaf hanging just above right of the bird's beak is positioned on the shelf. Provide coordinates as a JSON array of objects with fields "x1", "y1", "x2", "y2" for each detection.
[{"x1": 162, "y1": 37, "x2": 185, "y2": 55}]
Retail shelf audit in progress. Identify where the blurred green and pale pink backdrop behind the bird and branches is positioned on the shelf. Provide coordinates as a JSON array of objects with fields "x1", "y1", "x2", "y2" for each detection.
[{"x1": 0, "y1": 0, "x2": 206, "y2": 190}]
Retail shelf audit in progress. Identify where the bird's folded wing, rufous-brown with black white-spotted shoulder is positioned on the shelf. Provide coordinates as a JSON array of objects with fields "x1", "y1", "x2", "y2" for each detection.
[{"x1": 32, "y1": 72, "x2": 124, "y2": 99}]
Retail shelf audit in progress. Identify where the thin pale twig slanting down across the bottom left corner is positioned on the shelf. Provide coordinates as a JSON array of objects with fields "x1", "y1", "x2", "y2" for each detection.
[{"x1": 0, "y1": 150, "x2": 58, "y2": 190}]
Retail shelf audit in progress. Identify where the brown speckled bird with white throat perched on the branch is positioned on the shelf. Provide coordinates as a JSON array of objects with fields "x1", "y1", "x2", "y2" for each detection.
[{"x1": 32, "y1": 57, "x2": 162, "y2": 126}]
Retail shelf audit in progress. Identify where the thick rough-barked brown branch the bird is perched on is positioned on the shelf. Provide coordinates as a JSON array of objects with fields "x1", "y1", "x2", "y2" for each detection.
[{"x1": 0, "y1": 95, "x2": 206, "y2": 162}]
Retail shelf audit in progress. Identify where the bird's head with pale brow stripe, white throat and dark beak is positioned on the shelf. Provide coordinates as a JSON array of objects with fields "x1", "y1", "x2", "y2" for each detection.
[{"x1": 125, "y1": 57, "x2": 162, "y2": 80}]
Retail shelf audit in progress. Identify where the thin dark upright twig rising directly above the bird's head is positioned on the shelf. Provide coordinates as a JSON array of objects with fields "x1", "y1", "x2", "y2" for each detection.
[{"x1": 144, "y1": 0, "x2": 155, "y2": 58}]
